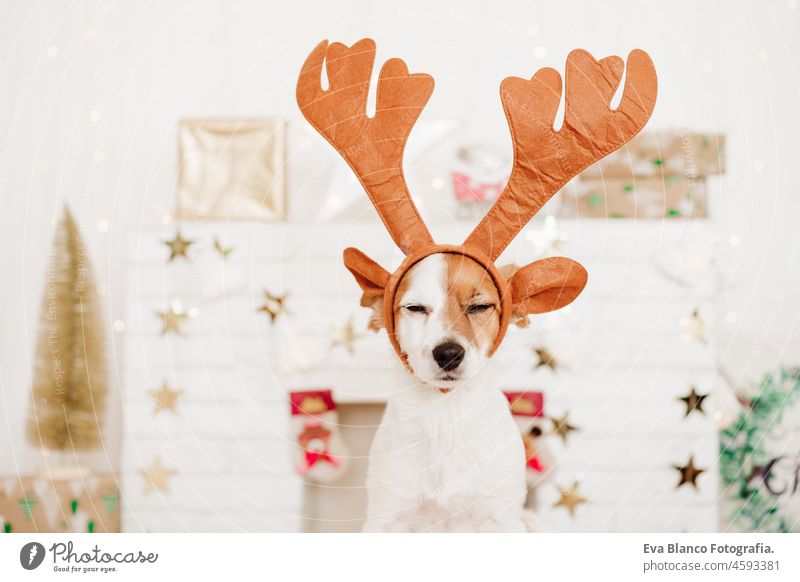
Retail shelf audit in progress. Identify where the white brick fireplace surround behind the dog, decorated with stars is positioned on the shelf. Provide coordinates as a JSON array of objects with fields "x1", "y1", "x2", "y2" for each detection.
[{"x1": 123, "y1": 220, "x2": 718, "y2": 531}]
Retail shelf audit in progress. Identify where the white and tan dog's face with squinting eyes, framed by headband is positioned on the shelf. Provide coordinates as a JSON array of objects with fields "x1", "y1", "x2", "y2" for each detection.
[{"x1": 393, "y1": 253, "x2": 500, "y2": 390}]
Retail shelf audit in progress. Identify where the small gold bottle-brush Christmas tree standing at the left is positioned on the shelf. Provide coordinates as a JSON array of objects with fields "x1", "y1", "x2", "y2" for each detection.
[{"x1": 27, "y1": 207, "x2": 108, "y2": 451}]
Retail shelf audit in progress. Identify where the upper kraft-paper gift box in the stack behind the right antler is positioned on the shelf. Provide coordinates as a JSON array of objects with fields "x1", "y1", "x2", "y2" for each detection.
[{"x1": 580, "y1": 131, "x2": 725, "y2": 180}]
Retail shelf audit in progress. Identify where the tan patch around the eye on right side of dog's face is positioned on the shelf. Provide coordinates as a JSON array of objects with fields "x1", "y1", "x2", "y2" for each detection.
[{"x1": 445, "y1": 254, "x2": 500, "y2": 348}]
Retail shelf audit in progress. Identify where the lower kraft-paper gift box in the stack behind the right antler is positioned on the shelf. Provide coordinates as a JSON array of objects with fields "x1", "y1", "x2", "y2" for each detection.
[{"x1": 560, "y1": 176, "x2": 708, "y2": 218}]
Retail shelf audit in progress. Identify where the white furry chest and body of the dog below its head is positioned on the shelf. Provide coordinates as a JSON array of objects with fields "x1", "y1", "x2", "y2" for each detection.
[{"x1": 365, "y1": 386, "x2": 525, "y2": 531}]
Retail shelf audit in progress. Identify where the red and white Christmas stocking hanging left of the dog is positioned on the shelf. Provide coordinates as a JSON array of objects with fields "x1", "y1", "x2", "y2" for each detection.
[{"x1": 289, "y1": 390, "x2": 347, "y2": 483}]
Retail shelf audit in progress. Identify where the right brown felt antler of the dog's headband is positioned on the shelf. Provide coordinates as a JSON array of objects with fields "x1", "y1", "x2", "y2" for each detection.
[{"x1": 464, "y1": 50, "x2": 657, "y2": 260}]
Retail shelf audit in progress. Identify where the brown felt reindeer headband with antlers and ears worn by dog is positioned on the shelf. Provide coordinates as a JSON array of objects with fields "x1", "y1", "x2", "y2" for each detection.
[{"x1": 297, "y1": 39, "x2": 657, "y2": 359}]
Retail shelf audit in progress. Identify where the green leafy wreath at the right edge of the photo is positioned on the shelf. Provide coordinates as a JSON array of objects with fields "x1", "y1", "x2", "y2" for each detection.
[{"x1": 719, "y1": 368, "x2": 800, "y2": 532}]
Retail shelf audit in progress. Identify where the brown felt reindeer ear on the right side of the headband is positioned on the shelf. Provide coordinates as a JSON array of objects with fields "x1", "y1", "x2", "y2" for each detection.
[{"x1": 510, "y1": 257, "x2": 587, "y2": 313}]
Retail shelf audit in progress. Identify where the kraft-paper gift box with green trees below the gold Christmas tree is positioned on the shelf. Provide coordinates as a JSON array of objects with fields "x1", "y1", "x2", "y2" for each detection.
[{"x1": 0, "y1": 474, "x2": 120, "y2": 533}]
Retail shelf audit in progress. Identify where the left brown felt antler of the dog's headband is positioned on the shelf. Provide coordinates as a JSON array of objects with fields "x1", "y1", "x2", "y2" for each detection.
[{"x1": 297, "y1": 39, "x2": 433, "y2": 254}]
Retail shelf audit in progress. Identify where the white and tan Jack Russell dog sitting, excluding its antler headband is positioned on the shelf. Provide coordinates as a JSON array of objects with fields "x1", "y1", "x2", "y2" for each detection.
[{"x1": 364, "y1": 253, "x2": 529, "y2": 532}]
